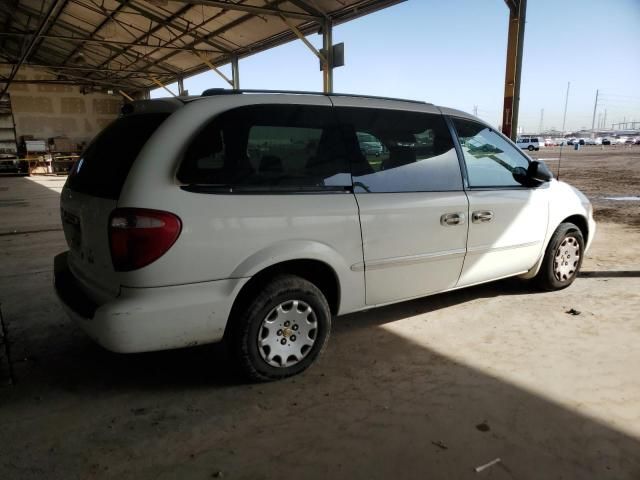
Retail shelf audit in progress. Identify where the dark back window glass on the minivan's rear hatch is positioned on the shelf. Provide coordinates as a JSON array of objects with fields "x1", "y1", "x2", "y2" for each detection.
[{"x1": 66, "y1": 113, "x2": 169, "y2": 200}]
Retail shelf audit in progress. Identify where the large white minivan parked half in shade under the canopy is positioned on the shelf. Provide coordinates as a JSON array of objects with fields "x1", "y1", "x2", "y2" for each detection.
[{"x1": 54, "y1": 90, "x2": 595, "y2": 380}]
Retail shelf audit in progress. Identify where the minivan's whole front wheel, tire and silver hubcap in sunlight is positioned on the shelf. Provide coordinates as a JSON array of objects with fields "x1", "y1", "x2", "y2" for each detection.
[{"x1": 536, "y1": 222, "x2": 584, "y2": 291}]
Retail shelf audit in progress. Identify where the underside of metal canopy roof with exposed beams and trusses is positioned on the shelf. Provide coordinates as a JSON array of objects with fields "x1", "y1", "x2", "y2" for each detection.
[{"x1": 0, "y1": 0, "x2": 404, "y2": 92}]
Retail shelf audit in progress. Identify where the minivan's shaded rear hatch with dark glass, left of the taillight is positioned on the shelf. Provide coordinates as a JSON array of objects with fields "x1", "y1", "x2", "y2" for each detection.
[{"x1": 60, "y1": 113, "x2": 169, "y2": 303}]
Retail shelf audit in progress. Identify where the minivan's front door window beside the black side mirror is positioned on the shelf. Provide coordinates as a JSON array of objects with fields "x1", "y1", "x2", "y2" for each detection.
[{"x1": 453, "y1": 119, "x2": 529, "y2": 187}]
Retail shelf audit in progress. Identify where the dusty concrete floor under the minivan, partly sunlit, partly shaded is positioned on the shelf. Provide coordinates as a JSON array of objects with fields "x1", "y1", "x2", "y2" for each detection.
[{"x1": 0, "y1": 177, "x2": 640, "y2": 480}]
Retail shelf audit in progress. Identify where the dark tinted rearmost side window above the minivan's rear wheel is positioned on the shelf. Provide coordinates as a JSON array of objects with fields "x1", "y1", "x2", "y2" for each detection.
[{"x1": 178, "y1": 105, "x2": 351, "y2": 190}]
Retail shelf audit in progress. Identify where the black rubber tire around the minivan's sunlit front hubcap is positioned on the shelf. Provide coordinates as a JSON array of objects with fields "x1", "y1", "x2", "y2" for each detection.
[{"x1": 535, "y1": 222, "x2": 584, "y2": 291}]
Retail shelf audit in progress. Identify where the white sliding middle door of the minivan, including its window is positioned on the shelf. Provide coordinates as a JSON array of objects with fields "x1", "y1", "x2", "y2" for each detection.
[{"x1": 334, "y1": 105, "x2": 468, "y2": 305}]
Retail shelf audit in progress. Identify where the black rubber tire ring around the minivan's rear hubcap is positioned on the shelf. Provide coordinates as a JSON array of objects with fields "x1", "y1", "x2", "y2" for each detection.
[{"x1": 229, "y1": 275, "x2": 331, "y2": 382}]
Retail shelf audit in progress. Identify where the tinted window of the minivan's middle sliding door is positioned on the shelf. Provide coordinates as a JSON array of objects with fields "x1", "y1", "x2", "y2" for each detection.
[{"x1": 337, "y1": 107, "x2": 462, "y2": 193}]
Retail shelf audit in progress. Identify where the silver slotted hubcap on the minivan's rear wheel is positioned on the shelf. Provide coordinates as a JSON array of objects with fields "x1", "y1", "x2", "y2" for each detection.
[{"x1": 258, "y1": 300, "x2": 318, "y2": 368}]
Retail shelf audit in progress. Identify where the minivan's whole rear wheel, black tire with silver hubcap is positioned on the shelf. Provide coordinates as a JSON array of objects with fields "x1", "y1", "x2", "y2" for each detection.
[{"x1": 230, "y1": 275, "x2": 331, "y2": 381}]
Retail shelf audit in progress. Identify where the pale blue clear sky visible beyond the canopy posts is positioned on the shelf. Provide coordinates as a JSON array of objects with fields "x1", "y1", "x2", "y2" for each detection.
[{"x1": 152, "y1": 0, "x2": 640, "y2": 132}]
